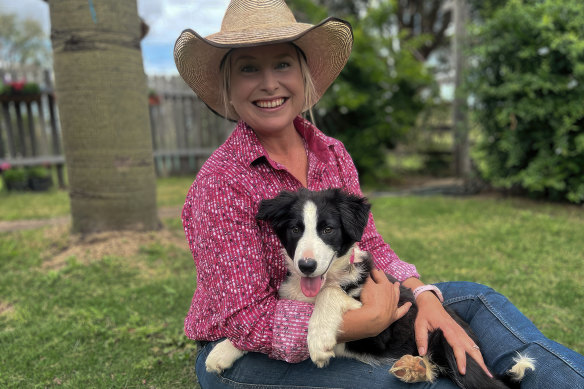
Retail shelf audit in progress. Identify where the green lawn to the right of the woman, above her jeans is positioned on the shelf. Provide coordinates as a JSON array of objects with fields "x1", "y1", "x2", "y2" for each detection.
[{"x1": 373, "y1": 197, "x2": 584, "y2": 353}]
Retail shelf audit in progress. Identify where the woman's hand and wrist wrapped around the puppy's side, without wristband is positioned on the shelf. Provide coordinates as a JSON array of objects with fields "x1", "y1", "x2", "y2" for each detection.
[{"x1": 337, "y1": 269, "x2": 412, "y2": 343}]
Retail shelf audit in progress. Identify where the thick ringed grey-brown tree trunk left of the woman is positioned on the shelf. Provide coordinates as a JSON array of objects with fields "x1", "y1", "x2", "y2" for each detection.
[{"x1": 48, "y1": 0, "x2": 159, "y2": 233}]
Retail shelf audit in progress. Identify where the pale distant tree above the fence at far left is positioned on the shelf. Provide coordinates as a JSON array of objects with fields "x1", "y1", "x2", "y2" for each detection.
[{"x1": 0, "y1": 14, "x2": 51, "y2": 71}]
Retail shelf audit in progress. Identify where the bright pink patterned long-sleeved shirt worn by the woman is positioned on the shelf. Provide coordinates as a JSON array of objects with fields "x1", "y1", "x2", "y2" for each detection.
[{"x1": 182, "y1": 117, "x2": 418, "y2": 362}]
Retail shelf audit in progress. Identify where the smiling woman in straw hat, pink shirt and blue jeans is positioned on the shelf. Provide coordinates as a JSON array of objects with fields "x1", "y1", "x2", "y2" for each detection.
[{"x1": 174, "y1": 0, "x2": 584, "y2": 388}]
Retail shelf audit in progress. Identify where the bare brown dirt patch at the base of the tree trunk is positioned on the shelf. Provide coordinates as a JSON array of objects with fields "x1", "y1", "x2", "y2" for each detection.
[{"x1": 42, "y1": 221, "x2": 188, "y2": 270}]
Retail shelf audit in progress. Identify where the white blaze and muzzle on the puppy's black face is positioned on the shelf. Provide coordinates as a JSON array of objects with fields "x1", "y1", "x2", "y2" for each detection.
[{"x1": 294, "y1": 201, "x2": 335, "y2": 277}]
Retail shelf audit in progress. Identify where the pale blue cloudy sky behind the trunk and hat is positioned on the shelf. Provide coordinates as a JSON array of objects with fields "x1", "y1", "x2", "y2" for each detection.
[{"x1": 0, "y1": 0, "x2": 229, "y2": 75}]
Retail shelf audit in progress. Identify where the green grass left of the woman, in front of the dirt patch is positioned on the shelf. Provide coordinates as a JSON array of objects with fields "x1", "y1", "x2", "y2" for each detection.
[{"x1": 0, "y1": 221, "x2": 196, "y2": 388}]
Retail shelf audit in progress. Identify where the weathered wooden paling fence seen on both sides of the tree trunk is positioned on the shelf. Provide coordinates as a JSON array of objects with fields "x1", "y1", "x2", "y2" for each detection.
[{"x1": 0, "y1": 71, "x2": 234, "y2": 187}]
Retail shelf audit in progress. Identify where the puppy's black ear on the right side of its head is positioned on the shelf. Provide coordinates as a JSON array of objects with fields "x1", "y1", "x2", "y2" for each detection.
[{"x1": 336, "y1": 190, "x2": 371, "y2": 242}]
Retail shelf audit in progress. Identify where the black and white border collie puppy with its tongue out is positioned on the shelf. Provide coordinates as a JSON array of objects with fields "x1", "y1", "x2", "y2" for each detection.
[{"x1": 206, "y1": 189, "x2": 533, "y2": 389}]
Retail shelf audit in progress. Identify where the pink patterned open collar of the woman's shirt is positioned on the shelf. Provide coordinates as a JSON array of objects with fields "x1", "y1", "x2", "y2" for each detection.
[{"x1": 234, "y1": 116, "x2": 334, "y2": 168}]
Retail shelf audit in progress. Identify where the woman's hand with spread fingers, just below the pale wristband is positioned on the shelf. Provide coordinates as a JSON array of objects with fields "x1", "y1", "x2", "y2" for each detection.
[{"x1": 415, "y1": 292, "x2": 492, "y2": 377}]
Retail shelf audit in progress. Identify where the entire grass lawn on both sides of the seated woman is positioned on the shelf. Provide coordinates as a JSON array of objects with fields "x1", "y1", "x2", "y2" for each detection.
[{"x1": 0, "y1": 179, "x2": 584, "y2": 388}]
